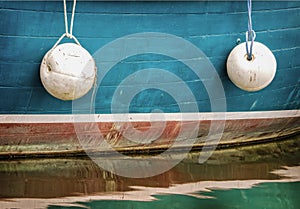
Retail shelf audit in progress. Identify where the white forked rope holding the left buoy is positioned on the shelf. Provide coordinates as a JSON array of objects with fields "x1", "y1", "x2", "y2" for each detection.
[{"x1": 52, "y1": 0, "x2": 81, "y2": 48}]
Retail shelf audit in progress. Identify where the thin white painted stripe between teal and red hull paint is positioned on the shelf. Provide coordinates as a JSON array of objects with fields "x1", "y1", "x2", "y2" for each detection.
[{"x1": 0, "y1": 110, "x2": 300, "y2": 123}]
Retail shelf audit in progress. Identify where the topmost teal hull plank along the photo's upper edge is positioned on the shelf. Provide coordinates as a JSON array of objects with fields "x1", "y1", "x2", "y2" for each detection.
[{"x1": 0, "y1": 1, "x2": 300, "y2": 14}]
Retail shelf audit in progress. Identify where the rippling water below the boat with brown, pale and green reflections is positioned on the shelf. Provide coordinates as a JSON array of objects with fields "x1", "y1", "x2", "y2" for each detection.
[{"x1": 0, "y1": 136, "x2": 300, "y2": 209}]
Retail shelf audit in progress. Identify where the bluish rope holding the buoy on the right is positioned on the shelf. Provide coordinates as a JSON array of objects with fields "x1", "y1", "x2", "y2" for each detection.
[{"x1": 246, "y1": 0, "x2": 256, "y2": 60}]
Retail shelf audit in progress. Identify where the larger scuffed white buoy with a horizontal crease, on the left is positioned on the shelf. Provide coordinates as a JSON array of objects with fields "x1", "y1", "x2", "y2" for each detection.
[{"x1": 40, "y1": 43, "x2": 97, "y2": 100}]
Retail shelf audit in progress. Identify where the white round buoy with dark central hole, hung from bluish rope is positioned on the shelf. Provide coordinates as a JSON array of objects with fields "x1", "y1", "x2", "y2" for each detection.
[{"x1": 227, "y1": 41, "x2": 277, "y2": 91}]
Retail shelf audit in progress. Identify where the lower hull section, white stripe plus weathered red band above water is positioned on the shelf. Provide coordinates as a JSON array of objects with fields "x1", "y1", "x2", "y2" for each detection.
[{"x1": 0, "y1": 110, "x2": 300, "y2": 158}]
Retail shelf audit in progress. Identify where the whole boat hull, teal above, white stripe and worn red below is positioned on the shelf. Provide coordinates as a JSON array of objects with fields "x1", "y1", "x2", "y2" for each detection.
[{"x1": 0, "y1": 1, "x2": 300, "y2": 157}]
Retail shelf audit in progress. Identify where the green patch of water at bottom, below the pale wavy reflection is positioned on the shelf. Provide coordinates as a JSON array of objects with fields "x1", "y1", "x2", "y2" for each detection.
[{"x1": 48, "y1": 182, "x2": 300, "y2": 209}]
